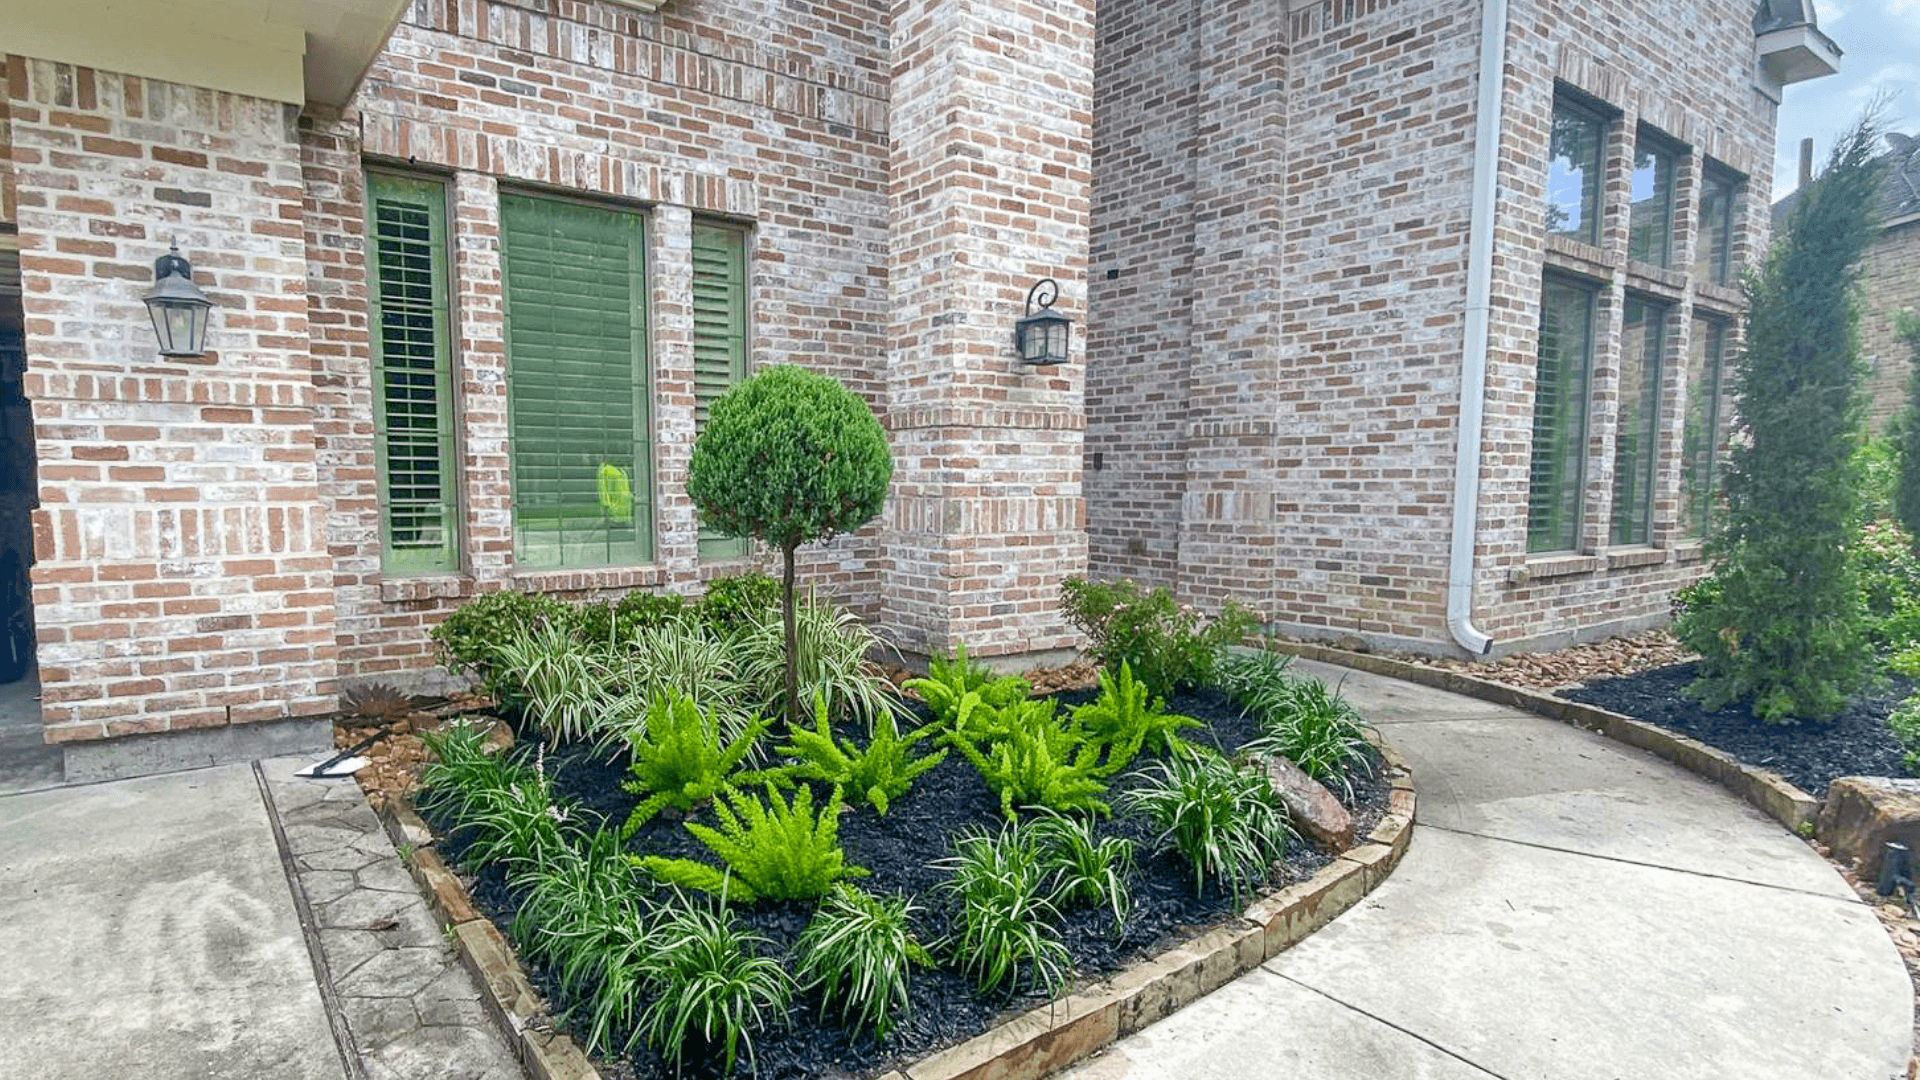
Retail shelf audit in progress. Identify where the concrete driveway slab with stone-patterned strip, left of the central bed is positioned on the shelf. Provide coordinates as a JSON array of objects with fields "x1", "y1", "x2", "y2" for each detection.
[{"x1": 0, "y1": 759, "x2": 520, "y2": 1080}]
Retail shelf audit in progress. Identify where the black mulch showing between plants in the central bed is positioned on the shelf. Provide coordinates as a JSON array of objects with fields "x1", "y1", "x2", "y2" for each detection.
[{"x1": 420, "y1": 690, "x2": 1388, "y2": 1080}]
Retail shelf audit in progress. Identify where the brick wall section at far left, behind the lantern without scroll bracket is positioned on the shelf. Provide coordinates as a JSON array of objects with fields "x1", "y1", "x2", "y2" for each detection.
[{"x1": 6, "y1": 56, "x2": 334, "y2": 742}]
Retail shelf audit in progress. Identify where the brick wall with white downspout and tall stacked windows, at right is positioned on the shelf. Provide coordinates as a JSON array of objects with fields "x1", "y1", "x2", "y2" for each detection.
[{"x1": 1087, "y1": 0, "x2": 1774, "y2": 651}]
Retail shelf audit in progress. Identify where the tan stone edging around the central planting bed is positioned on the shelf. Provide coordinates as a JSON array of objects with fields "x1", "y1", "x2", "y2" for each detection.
[{"x1": 380, "y1": 736, "x2": 1417, "y2": 1080}]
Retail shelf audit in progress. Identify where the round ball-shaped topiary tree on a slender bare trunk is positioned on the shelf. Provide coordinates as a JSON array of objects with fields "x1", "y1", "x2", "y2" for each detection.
[{"x1": 687, "y1": 363, "x2": 893, "y2": 723}]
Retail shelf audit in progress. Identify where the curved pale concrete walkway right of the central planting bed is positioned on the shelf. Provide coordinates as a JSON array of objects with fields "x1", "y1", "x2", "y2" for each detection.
[{"x1": 1068, "y1": 663, "x2": 1912, "y2": 1080}]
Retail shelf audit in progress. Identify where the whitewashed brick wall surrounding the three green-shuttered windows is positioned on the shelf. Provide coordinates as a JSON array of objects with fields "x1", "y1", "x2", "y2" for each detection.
[{"x1": 301, "y1": 0, "x2": 887, "y2": 684}]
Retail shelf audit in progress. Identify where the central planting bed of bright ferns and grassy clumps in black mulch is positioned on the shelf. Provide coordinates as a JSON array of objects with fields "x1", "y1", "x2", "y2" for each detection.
[{"x1": 422, "y1": 576, "x2": 1388, "y2": 1076}]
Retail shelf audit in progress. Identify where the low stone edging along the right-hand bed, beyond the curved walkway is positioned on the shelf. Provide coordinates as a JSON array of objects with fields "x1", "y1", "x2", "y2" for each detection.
[{"x1": 1273, "y1": 642, "x2": 1820, "y2": 834}]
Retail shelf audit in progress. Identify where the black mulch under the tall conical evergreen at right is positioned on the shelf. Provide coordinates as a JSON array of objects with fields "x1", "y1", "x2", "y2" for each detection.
[{"x1": 1559, "y1": 663, "x2": 1912, "y2": 798}]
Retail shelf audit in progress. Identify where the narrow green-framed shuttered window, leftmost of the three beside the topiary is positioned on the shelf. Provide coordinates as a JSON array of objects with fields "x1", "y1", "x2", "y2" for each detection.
[{"x1": 367, "y1": 173, "x2": 459, "y2": 573}]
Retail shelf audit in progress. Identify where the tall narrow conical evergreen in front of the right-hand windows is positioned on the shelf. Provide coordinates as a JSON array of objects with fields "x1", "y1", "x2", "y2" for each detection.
[{"x1": 1674, "y1": 113, "x2": 1880, "y2": 723}]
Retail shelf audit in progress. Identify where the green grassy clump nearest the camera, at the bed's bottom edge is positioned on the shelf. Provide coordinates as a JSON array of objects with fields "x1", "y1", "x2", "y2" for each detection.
[{"x1": 634, "y1": 897, "x2": 795, "y2": 1072}]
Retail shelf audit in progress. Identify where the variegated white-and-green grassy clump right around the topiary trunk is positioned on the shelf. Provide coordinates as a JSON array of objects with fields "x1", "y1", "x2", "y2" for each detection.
[{"x1": 735, "y1": 603, "x2": 902, "y2": 730}]
